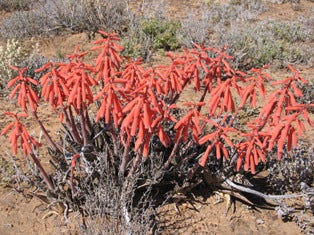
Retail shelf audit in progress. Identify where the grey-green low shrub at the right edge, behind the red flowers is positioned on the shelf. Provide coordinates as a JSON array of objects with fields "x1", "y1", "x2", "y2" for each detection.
[{"x1": 217, "y1": 21, "x2": 314, "y2": 68}]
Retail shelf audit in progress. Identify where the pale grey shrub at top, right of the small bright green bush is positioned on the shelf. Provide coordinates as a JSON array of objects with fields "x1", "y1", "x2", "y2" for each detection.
[{"x1": 178, "y1": 0, "x2": 265, "y2": 47}]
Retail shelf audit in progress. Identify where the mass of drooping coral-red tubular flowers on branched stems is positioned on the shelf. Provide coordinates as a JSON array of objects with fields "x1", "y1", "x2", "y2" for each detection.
[{"x1": 1, "y1": 31, "x2": 313, "y2": 196}]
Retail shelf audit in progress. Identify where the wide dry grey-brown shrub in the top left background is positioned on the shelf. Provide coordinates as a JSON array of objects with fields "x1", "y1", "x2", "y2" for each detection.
[{"x1": 0, "y1": 0, "x2": 131, "y2": 38}]
